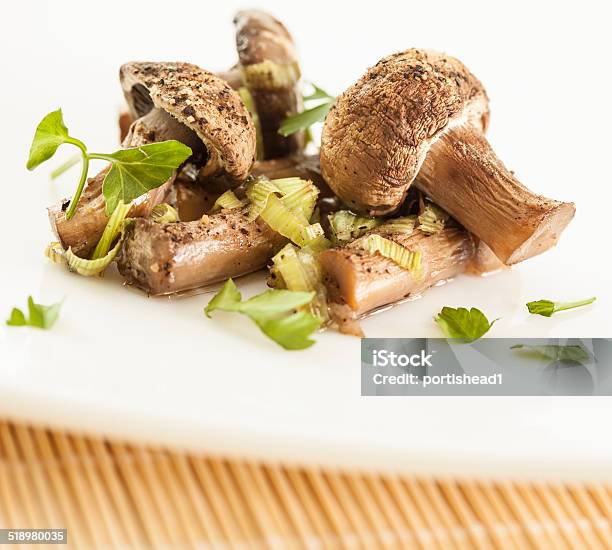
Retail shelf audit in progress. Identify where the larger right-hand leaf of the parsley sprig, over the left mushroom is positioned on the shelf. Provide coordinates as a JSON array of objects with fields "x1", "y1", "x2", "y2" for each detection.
[{"x1": 94, "y1": 140, "x2": 191, "y2": 216}]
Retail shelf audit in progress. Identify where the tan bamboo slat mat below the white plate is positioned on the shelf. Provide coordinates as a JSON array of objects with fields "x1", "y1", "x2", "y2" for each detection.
[{"x1": 0, "y1": 422, "x2": 612, "y2": 550}]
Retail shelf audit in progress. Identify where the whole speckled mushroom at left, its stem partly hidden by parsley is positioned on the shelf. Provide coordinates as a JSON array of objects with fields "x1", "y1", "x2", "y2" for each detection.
[{"x1": 49, "y1": 63, "x2": 255, "y2": 256}]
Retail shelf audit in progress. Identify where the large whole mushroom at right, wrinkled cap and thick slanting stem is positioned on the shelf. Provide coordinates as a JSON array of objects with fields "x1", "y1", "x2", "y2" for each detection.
[{"x1": 321, "y1": 49, "x2": 575, "y2": 265}]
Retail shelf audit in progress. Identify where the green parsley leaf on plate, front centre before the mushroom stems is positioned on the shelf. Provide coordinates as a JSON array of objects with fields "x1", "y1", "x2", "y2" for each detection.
[{"x1": 204, "y1": 279, "x2": 321, "y2": 350}]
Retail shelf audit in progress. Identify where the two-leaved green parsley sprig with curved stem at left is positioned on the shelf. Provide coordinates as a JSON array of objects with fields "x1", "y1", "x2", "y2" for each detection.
[{"x1": 27, "y1": 109, "x2": 191, "y2": 219}]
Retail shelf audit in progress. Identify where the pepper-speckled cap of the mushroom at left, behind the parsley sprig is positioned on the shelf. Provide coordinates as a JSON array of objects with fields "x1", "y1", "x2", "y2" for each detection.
[{"x1": 119, "y1": 62, "x2": 256, "y2": 182}]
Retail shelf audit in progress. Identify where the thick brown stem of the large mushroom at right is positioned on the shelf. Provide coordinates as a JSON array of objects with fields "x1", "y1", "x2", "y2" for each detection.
[{"x1": 415, "y1": 125, "x2": 575, "y2": 265}]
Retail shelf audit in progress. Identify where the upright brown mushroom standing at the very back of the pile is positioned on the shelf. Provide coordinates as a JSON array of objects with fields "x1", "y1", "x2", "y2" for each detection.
[{"x1": 234, "y1": 10, "x2": 304, "y2": 159}]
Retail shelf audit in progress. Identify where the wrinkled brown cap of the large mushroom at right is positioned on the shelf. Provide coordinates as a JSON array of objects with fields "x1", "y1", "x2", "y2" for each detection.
[{"x1": 321, "y1": 49, "x2": 489, "y2": 215}]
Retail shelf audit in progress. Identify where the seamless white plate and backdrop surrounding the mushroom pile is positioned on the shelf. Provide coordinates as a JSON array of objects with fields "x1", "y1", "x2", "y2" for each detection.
[{"x1": 0, "y1": 1, "x2": 612, "y2": 476}]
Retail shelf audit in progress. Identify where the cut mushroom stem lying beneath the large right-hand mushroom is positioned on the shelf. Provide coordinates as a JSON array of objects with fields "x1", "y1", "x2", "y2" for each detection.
[{"x1": 319, "y1": 226, "x2": 476, "y2": 322}]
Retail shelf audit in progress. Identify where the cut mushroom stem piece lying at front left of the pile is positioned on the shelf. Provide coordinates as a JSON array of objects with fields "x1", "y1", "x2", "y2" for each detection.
[{"x1": 117, "y1": 208, "x2": 286, "y2": 294}]
